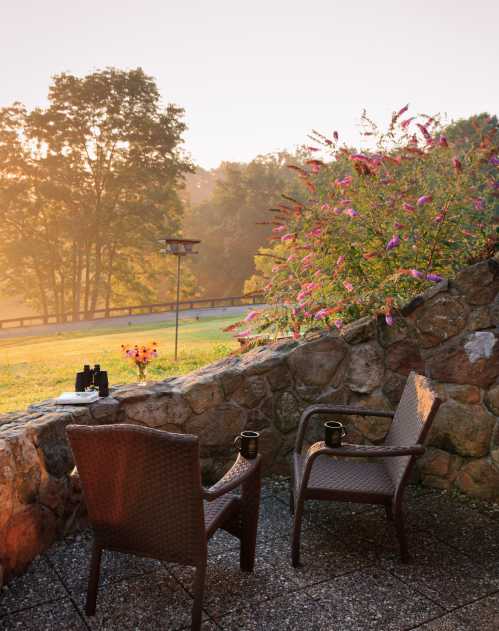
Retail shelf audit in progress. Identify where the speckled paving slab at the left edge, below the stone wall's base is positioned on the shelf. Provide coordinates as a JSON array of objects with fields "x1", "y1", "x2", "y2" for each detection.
[{"x1": 0, "y1": 557, "x2": 67, "y2": 616}]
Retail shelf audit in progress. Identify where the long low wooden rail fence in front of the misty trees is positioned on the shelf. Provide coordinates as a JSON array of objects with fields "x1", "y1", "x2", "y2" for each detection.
[{"x1": 0, "y1": 295, "x2": 263, "y2": 329}]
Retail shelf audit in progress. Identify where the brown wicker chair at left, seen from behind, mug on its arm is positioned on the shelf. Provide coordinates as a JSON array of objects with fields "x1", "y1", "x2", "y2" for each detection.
[{"x1": 67, "y1": 425, "x2": 260, "y2": 630}]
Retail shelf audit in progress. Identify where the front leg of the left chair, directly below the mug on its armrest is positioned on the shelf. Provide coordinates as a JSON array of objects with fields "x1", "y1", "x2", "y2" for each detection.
[{"x1": 239, "y1": 462, "x2": 260, "y2": 572}]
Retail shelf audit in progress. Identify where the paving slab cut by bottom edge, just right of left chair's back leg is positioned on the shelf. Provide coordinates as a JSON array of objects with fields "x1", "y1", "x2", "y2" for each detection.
[{"x1": 217, "y1": 592, "x2": 330, "y2": 631}]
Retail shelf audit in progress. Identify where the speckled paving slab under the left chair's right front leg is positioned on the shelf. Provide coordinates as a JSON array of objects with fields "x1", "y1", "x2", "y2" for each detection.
[{"x1": 169, "y1": 550, "x2": 298, "y2": 618}]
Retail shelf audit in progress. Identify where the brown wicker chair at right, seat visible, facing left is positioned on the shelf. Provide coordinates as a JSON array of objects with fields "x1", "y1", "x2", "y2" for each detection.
[{"x1": 290, "y1": 373, "x2": 440, "y2": 567}]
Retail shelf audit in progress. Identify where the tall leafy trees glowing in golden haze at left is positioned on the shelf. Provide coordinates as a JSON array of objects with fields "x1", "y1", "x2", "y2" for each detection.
[{"x1": 0, "y1": 68, "x2": 194, "y2": 320}]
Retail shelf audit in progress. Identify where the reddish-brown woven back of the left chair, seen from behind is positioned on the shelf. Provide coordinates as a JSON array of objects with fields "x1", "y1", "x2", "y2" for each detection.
[{"x1": 67, "y1": 425, "x2": 206, "y2": 565}]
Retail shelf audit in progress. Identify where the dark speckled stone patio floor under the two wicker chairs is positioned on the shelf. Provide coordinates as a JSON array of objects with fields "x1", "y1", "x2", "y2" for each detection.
[{"x1": 0, "y1": 478, "x2": 499, "y2": 631}]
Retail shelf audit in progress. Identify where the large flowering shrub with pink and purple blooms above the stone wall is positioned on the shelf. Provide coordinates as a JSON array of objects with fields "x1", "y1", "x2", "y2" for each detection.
[{"x1": 235, "y1": 106, "x2": 499, "y2": 337}]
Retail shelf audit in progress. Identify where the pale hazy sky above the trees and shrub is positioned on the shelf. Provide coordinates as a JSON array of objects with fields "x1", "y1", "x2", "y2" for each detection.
[{"x1": 0, "y1": 0, "x2": 499, "y2": 167}]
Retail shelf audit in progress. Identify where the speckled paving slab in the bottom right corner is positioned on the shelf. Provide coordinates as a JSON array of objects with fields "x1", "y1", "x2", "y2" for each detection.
[{"x1": 418, "y1": 594, "x2": 499, "y2": 631}]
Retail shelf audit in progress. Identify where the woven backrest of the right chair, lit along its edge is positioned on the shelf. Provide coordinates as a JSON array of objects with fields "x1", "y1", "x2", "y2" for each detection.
[{"x1": 385, "y1": 372, "x2": 439, "y2": 488}]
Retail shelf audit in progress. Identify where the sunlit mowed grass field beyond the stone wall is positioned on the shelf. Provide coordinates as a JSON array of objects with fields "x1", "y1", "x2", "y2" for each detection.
[{"x1": 0, "y1": 315, "x2": 240, "y2": 412}]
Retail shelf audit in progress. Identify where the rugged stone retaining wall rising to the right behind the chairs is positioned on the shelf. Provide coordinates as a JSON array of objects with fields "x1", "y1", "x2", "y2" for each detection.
[{"x1": 0, "y1": 259, "x2": 499, "y2": 574}]
